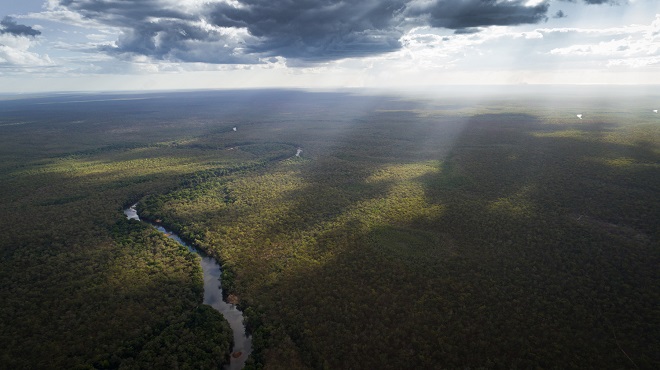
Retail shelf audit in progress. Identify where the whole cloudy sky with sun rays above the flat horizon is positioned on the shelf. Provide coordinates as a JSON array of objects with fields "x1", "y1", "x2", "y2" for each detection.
[{"x1": 0, "y1": 0, "x2": 660, "y2": 93}]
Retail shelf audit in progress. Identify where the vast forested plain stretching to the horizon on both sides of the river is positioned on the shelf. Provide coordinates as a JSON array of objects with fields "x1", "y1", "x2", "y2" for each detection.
[{"x1": 0, "y1": 91, "x2": 660, "y2": 369}]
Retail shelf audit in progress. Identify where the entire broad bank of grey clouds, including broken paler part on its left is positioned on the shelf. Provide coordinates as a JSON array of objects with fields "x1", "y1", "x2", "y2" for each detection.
[{"x1": 55, "y1": 0, "x2": 564, "y2": 63}]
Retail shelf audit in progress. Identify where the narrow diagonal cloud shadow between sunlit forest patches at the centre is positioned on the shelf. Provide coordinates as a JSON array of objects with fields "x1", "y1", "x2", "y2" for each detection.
[{"x1": 258, "y1": 107, "x2": 460, "y2": 243}]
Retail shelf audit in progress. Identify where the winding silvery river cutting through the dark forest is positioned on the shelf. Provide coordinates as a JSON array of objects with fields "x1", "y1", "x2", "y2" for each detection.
[{"x1": 124, "y1": 204, "x2": 252, "y2": 370}]
